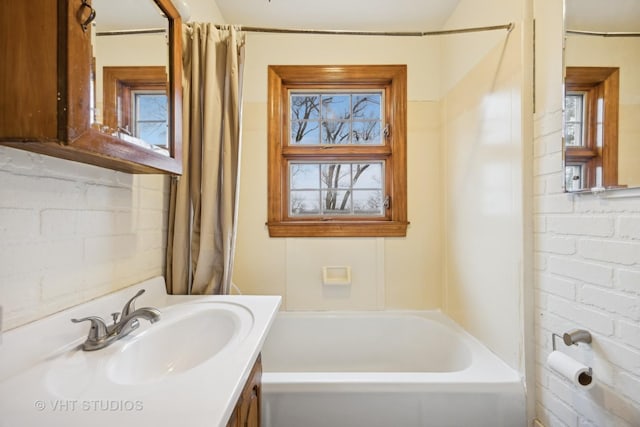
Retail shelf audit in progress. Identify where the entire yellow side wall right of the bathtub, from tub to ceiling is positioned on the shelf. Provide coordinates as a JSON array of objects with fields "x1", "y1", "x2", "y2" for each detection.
[{"x1": 441, "y1": 0, "x2": 531, "y2": 372}]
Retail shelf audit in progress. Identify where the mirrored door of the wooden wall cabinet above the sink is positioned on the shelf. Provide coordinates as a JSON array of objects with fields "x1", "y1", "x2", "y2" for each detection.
[{"x1": 91, "y1": 0, "x2": 181, "y2": 174}]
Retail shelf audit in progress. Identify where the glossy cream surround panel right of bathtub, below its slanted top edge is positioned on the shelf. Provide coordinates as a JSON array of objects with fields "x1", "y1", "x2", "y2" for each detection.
[{"x1": 443, "y1": 25, "x2": 523, "y2": 367}]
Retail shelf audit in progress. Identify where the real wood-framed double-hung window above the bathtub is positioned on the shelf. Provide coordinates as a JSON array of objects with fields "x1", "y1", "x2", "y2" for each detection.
[{"x1": 267, "y1": 65, "x2": 408, "y2": 237}]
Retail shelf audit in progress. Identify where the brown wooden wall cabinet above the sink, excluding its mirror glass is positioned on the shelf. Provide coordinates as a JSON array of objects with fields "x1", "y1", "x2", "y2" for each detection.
[{"x1": 0, "y1": 0, "x2": 182, "y2": 175}]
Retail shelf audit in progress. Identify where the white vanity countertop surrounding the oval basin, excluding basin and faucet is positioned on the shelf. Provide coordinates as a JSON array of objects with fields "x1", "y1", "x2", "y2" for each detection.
[{"x1": 0, "y1": 278, "x2": 280, "y2": 427}]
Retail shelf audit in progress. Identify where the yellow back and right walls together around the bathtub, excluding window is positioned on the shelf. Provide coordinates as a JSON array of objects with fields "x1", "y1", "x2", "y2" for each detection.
[{"x1": 234, "y1": 2, "x2": 530, "y2": 378}]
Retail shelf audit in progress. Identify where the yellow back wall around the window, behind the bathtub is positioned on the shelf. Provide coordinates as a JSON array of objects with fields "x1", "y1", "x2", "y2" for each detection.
[{"x1": 234, "y1": 33, "x2": 443, "y2": 310}]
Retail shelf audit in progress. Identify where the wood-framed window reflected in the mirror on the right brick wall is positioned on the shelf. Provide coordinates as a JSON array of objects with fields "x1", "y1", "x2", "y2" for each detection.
[{"x1": 564, "y1": 67, "x2": 619, "y2": 191}]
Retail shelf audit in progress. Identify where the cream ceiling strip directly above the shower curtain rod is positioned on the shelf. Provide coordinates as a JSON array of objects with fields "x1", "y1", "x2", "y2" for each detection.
[{"x1": 214, "y1": 0, "x2": 460, "y2": 31}]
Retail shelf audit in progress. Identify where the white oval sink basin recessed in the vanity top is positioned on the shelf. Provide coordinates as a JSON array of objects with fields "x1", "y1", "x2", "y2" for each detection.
[{"x1": 107, "y1": 302, "x2": 253, "y2": 384}]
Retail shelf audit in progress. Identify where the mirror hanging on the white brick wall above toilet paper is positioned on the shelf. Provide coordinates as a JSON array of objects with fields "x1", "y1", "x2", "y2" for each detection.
[{"x1": 564, "y1": 0, "x2": 640, "y2": 191}]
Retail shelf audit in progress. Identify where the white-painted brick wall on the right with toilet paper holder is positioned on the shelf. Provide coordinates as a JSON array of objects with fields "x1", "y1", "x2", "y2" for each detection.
[{"x1": 534, "y1": 0, "x2": 640, "y2": 427}]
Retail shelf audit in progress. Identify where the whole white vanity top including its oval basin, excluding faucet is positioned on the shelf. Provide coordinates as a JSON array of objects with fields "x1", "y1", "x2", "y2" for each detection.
[{"x1": 0, "y1": 277, "x2": 280, "y2": 427}]
